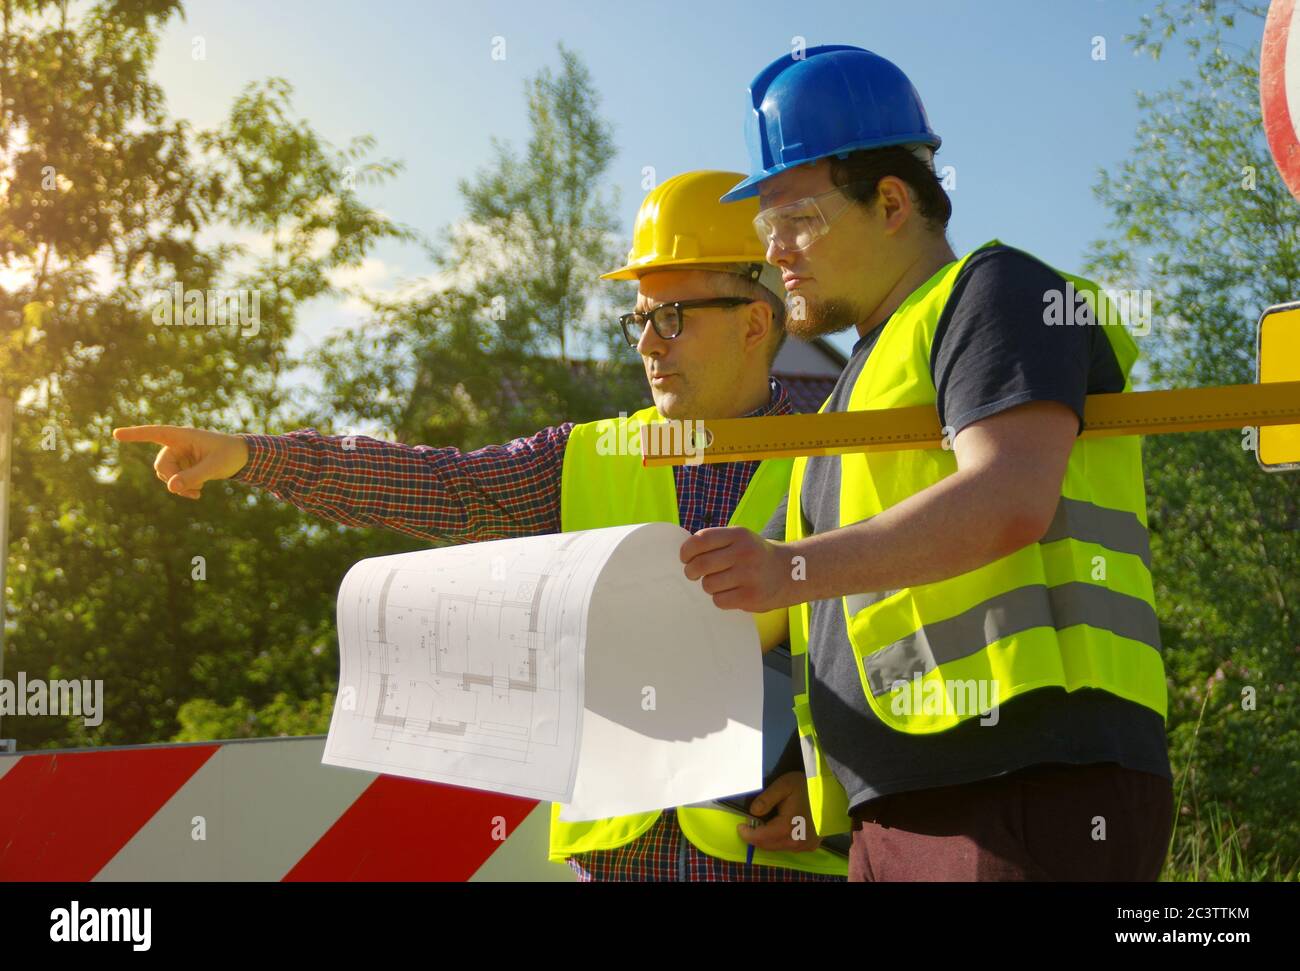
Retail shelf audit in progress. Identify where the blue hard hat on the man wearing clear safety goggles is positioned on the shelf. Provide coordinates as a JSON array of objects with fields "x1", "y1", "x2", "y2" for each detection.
[{"x1": 722, "y1": 44, "x2": 940, "y2": 203}]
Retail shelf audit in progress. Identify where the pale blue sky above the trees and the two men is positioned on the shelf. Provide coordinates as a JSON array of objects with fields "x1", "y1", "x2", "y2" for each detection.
[{"x1": 147, "y1": 0, "x2": 1257, "y2": 356}]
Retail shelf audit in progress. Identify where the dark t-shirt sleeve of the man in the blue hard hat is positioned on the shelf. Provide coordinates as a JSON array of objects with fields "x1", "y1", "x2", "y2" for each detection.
[{"x1": 931, "y1": 248, "x2": 1123, "y2": 434}]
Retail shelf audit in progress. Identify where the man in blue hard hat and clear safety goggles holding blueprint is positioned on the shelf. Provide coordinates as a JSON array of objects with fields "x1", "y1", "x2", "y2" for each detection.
[{"x1": 681, "y1": 45, "x2": 1173, "y2": 880}]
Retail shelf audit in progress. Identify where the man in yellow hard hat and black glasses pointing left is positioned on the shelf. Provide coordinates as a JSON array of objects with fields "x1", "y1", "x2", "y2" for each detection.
[{"x1": 114, "y1": 172, "x2": 846, "y2": 880}]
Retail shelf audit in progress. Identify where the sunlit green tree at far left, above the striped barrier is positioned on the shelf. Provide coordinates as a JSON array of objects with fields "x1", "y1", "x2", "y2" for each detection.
[{"x1": 0, "y1": 0, "x2": 412, "y2": 747}]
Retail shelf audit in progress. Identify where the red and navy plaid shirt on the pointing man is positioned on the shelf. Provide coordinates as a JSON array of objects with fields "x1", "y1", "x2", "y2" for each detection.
[{"x1": 231, "y1": 378, "x2": 839, "y2": 880}]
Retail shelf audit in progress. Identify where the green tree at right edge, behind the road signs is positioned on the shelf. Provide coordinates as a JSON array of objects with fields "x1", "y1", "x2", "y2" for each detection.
[{"x1": 1089, "y1": 0, "x2": 1300, "y2": 879}]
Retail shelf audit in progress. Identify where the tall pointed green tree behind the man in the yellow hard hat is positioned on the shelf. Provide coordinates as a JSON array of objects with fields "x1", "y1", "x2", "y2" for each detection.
[{"x1": 310, "y1": 47, "x2": 647, "y2": 447}]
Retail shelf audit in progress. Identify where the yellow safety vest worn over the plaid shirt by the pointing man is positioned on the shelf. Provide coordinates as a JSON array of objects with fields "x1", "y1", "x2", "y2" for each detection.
[{"x1": 550, "y1": 408, "x2": 848, "y2": 876}]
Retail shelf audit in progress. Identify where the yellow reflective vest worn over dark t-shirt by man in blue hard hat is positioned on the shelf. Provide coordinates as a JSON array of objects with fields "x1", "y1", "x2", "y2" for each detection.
[{"x1": 785, "y1": 239, "x2": 1166, "y2": 836}]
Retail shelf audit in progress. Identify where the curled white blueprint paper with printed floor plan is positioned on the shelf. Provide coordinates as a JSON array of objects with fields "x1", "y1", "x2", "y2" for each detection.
[{"x1": 324, "y1": 523, "x2": 763, "y2": 820}]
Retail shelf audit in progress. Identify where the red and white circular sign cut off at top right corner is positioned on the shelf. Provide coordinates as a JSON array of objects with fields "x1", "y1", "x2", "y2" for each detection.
[{"x1": 1260, "y1": 0, "x2": 1300, "y2": 199}]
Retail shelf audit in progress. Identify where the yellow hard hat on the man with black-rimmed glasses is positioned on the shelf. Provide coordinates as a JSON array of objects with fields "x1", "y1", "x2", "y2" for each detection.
[{"x1": 601, "y1": 172, "x2": 784, "y2": 296}]
